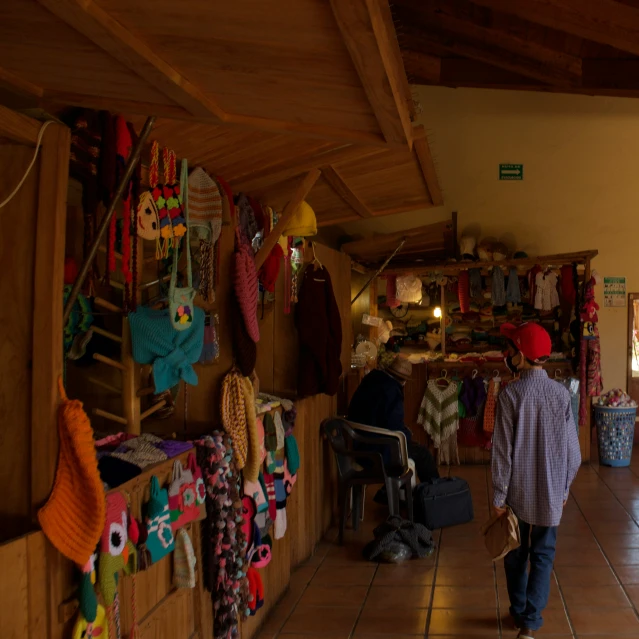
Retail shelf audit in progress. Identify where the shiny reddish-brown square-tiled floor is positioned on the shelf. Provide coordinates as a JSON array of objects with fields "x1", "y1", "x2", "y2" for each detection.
[{"x1": 259, "y1": 450, "x2": 639, "y2": 639}]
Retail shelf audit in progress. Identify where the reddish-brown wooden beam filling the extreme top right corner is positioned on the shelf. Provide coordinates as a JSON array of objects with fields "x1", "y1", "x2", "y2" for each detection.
[{"x1": 473, "y1": 0, "x2": 639, "y2": 55}]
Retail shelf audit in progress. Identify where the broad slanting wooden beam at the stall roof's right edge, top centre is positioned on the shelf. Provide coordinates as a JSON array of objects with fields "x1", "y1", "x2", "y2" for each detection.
[{"x1": 330, "y1": 0, "x2": 412, "y2": 146}]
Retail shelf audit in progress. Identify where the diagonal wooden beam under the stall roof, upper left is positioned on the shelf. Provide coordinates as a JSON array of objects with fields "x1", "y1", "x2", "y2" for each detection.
[{"x1": 37, "y1": 0, "x2": 226, "y2": 122}]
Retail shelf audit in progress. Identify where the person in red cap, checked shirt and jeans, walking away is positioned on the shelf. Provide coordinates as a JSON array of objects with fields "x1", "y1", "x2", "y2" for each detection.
[{"x1": 492, "y1": 323, "x2": 581, "y2": 639}]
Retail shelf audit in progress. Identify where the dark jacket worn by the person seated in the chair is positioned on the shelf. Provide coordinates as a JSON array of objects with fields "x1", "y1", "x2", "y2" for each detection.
[{"x1": 348, "y1": 370, "x2": 411, "y2": 441}]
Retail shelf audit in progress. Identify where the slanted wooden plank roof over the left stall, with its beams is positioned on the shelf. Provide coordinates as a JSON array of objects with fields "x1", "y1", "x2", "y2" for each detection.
[{"x1": 0, "y1": 0, "x2": 442, "y2": 225}]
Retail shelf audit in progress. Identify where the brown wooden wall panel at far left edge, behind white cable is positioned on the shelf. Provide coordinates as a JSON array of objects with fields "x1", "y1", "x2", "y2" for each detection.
[{"x1": 0, "y1": 143, "x2": 39, "y2": 540}]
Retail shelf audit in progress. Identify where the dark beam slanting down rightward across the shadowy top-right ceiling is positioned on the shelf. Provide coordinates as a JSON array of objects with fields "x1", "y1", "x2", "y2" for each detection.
[{"x1": 396, "y1": 0, "x2": 581, "y2": 85}]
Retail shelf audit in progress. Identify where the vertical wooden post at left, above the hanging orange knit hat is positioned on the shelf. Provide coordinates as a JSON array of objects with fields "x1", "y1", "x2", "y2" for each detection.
[{"x1": 31, "y1": 124, "x2": 71, "y2": 516}]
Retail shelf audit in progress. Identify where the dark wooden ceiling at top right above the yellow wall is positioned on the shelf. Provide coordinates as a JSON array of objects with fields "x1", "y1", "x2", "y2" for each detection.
[{"x1": 393, "y1": 0, "x2": 639, "y2": 97}]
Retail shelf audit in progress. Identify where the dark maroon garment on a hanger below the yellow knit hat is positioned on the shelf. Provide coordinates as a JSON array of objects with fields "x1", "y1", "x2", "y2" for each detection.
[{"x1": 295, "y1": 264, "x2": 342, "y2": 397}]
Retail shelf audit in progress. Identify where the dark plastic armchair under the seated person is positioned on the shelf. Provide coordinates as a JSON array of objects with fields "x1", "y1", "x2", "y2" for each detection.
[{"x1": 322, "y1": 417, "x2": 413, "y2": 544}]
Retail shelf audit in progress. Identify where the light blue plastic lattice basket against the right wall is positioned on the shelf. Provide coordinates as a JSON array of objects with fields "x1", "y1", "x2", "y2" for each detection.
[{"x1": 594, "y1": 406, "x2": 637, "y2": 467}]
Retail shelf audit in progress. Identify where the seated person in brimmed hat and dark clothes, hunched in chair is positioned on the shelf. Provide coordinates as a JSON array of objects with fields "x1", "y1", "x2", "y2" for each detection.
[{"x1": 347, "y1": 357, "x2": 439, "y2": 488}]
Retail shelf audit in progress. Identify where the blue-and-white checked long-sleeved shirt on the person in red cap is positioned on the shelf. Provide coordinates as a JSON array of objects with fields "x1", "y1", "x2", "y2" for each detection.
[{"x1": 492, "y1": 369, "x2": 581, "y2": 526}]
